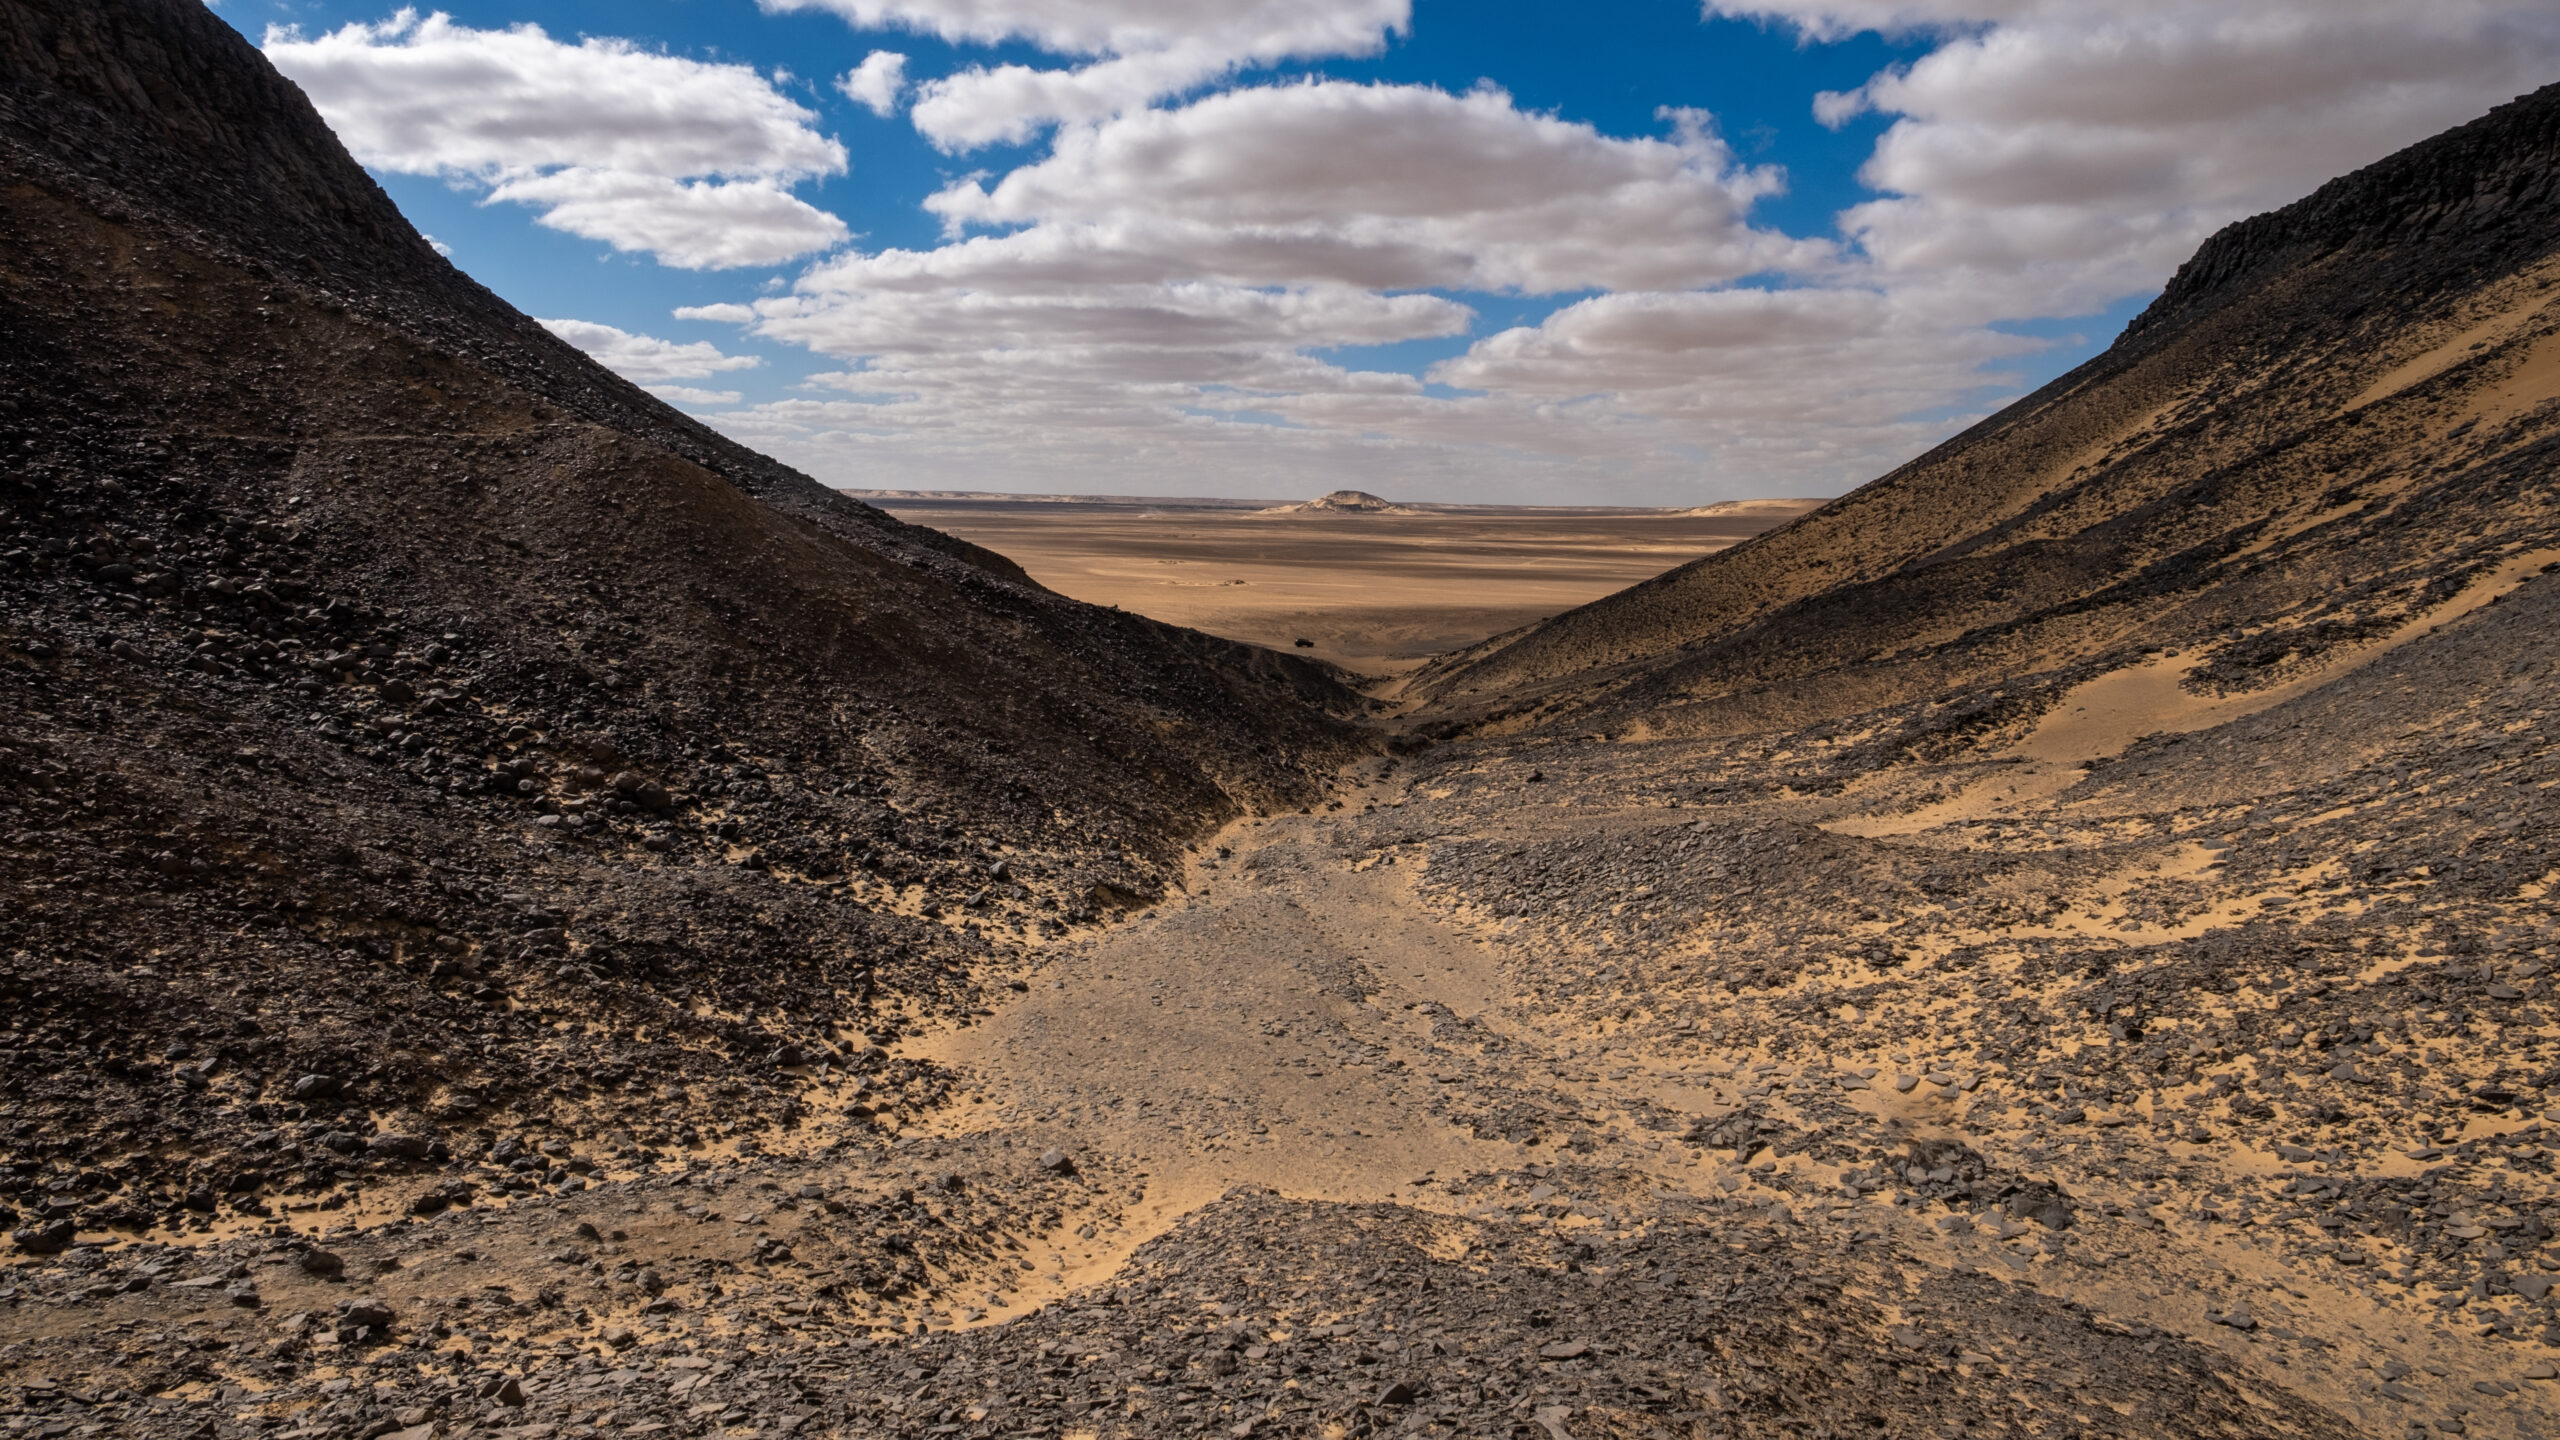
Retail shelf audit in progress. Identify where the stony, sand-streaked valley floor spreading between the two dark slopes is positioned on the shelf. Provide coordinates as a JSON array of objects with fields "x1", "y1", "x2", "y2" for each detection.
[{"x1": 13, "y1": 545, "x2": 2560, "y2": 1440}]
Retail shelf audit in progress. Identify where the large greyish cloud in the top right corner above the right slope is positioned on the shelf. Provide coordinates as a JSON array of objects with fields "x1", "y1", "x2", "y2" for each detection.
[{"x1": 1710, "y1": 0, "x2": 2560, "y2": 315}]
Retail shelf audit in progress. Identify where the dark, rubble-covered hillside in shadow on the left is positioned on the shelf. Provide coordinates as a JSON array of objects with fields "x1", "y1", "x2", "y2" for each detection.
[{"x1": 0, "y1": 0, "x2": 1354, "y2": 1225}]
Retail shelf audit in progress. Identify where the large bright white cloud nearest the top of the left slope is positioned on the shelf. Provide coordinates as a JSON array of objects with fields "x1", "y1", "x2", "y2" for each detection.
[{"x1": 264, "y1": 10, "x2": 847, "y2": 269}]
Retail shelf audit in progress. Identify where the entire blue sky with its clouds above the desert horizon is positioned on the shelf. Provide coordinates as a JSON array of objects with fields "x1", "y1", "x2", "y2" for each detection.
[{"x1": 220, "y1": 0, "x2": 2560, "y2": 505}]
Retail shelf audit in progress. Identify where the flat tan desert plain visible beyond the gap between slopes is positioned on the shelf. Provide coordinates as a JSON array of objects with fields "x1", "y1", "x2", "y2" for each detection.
[{"x1": 870, "y1": 489, "x2": 1823, "y2": 676}]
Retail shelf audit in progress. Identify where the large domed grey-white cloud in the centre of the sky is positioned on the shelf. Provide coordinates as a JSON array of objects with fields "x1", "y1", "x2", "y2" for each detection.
[{"x1": 927, "y1": 82, "x2": 1828, "y2": 292}]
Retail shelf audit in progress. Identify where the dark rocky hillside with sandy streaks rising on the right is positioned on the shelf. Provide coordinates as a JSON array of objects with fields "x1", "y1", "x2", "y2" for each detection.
[{"x1": 1413, "y1": 73, "x2": 2560, "y2": 733}]
